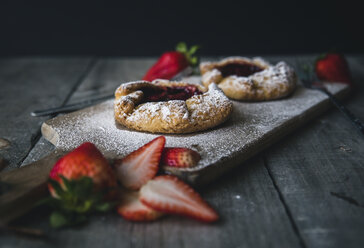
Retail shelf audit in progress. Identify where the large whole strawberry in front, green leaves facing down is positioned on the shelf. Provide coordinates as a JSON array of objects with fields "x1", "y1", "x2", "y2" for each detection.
[{"x1": 45, "y1": 142, "x2": 117, "y2": 228}]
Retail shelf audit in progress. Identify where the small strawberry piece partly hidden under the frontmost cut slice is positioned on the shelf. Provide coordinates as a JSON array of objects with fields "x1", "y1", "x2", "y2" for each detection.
[{"x1": 117, "y1": 191, "x2": 163, "y2": 221}]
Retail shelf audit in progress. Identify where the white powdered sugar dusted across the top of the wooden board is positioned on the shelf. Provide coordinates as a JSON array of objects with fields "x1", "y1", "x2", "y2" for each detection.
[{"x1": 49, "y1": 76, "x2": 346, "y2": 168}]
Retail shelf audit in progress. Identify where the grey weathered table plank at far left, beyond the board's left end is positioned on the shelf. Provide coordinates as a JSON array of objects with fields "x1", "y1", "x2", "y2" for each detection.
[{"x1": 0, "y1": 58, "x2": 90, "y2": 168}]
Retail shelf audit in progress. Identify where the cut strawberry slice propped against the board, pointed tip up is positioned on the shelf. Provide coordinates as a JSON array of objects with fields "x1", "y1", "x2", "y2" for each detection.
[{"x1": 115, "y1": 136, "x2": 166, "y2": 190}]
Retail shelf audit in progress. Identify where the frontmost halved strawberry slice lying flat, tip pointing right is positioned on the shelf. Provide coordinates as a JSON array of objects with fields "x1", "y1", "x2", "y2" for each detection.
[{"x1": 139, "y1": 175, "x2": 219, "y2": 222}]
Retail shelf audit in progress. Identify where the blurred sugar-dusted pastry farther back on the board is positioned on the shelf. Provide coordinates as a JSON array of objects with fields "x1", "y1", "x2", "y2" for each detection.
[{"x1": 200, "y1": 57, "x2": 297, "y2": 101}]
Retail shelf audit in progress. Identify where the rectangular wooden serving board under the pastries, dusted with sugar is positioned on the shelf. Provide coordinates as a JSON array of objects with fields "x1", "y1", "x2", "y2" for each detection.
[{"x1": 42, "y1": 77, "x2": 348, "y2": 184}]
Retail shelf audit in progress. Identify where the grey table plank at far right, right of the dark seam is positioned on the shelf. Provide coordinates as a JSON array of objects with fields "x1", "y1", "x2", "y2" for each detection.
[{"x1": 266, "y1": 58, "x2": 364, "y2": 247}]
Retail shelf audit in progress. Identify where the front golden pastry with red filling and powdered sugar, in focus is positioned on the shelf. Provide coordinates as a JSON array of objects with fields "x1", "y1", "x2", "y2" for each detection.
[{"x1": 114, "y1": 79, "x2": 233, "y2": 133}]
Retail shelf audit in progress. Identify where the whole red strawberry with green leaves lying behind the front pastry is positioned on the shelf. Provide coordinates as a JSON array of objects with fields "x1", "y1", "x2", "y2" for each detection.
[{"x1": 143, "y1": 42, "x2": 199, "y2": 81}]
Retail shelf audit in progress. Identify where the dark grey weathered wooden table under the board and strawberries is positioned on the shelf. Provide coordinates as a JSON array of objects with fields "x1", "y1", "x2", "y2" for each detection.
[{"x1": 0, "y1": 56, "x2": 364, "y2": 248}]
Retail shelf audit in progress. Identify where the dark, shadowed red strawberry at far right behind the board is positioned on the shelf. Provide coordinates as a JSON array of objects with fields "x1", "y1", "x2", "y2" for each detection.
[{"x1": 315, "y1": 53, "x2": 352, "y2": 85}]
